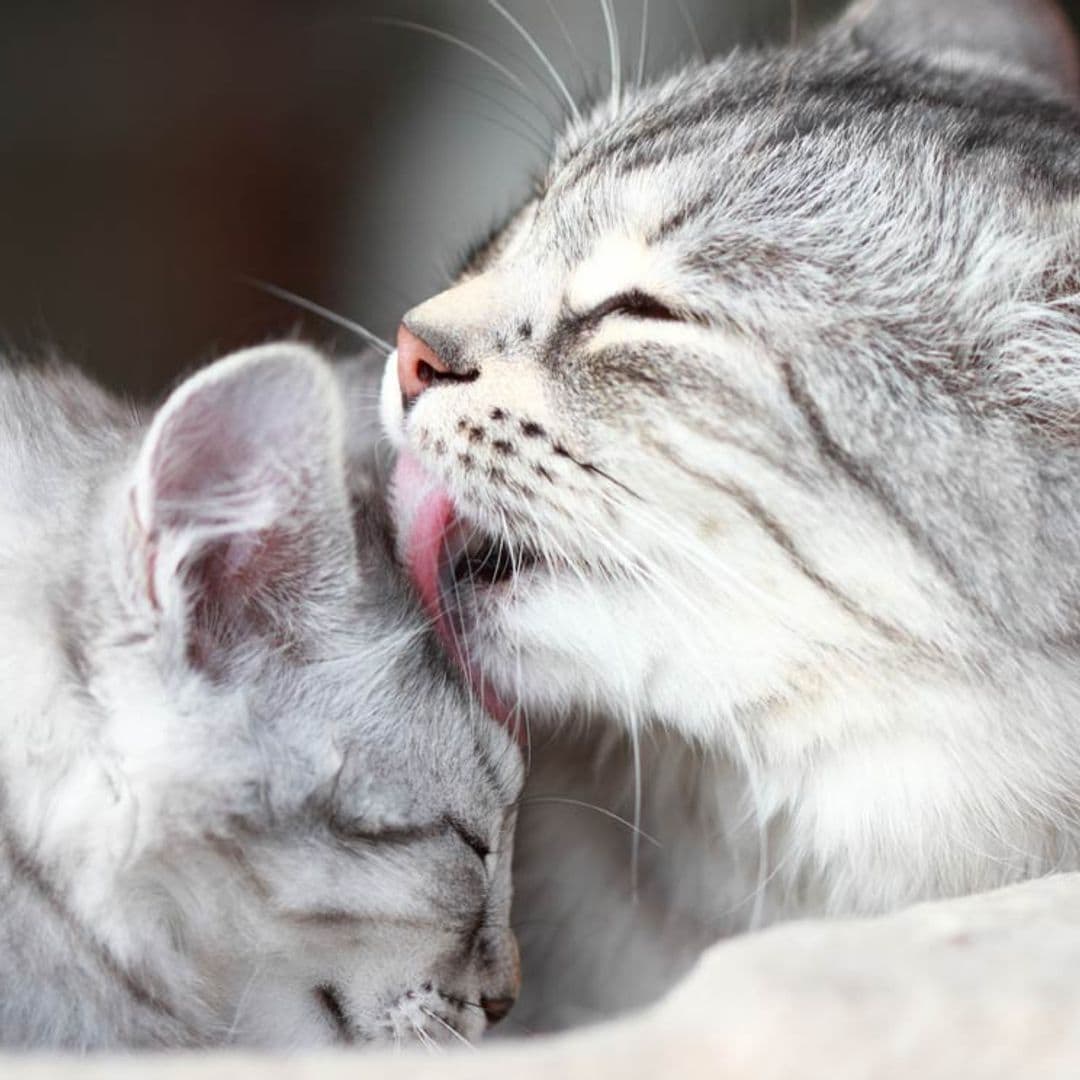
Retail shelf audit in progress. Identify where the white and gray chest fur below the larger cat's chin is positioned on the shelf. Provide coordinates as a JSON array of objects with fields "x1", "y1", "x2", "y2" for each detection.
[{"x1": 517, "y1": 665, "x2": 1080, "y2": 1028}]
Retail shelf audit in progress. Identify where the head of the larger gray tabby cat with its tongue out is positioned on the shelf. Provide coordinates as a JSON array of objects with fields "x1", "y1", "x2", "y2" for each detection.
[{"x1": 383, "y1": 0, "x2": 1080, "y2": 743}]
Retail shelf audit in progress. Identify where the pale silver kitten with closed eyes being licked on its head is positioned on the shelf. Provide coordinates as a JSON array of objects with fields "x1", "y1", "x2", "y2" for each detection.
[{"x1": 0, "y1": 345, "x2": 521, "y2": 1050}]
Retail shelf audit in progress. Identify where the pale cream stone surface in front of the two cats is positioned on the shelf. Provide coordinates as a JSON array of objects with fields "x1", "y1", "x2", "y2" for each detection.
[{"x1": 8, "y1": 875, "x2": 1080, "y2": 1080}]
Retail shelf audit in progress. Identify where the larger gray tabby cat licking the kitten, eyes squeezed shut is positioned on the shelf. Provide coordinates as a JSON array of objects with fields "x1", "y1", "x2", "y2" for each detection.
[{"x1": 381, "y1": 0, "x2": 1080, "y2": 1029}]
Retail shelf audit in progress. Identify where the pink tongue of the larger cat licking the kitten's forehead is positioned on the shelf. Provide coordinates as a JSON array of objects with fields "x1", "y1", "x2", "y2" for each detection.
[{"x1": 393, "y1": 451, "x2": 526, "y2": 745}]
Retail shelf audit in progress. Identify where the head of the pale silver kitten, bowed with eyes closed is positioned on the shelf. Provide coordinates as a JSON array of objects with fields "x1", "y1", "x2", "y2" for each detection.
[{"x1": 71, "y1": 345, "x2": 521, "y2": 1045}]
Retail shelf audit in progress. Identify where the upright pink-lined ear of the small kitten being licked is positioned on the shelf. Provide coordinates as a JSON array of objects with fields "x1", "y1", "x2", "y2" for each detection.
[{"x1": 127, "y1": 343, "x2": 352, "y2": 665}]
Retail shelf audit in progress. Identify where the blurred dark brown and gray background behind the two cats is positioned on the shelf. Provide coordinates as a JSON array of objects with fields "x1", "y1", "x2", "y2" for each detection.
[{"x1": 0, "y1": 0, "x2": 1080, "y2": 396}]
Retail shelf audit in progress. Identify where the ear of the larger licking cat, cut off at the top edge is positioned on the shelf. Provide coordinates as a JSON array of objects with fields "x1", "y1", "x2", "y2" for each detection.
[{"x1": 839, "y1": 0, "x2": 1080, "y2": 95}]
